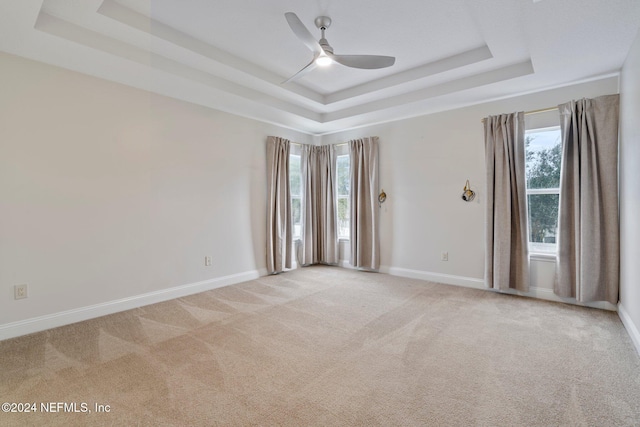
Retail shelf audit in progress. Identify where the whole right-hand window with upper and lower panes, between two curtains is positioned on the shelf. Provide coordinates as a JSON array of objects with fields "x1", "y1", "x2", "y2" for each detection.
[{"x1": 525, "y1": 126, "x2": 562, "y2": 253}]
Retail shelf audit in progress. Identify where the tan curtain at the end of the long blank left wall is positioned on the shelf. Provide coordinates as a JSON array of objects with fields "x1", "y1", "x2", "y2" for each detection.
[{"x1": 267, "y1": 136, "x2": 293, "y2": 274}]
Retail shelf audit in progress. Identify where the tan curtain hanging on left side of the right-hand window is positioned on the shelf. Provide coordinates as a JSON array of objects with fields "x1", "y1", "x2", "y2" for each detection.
[{"x1": 484, "y1": 112, "x2": 529, "y2": 292}]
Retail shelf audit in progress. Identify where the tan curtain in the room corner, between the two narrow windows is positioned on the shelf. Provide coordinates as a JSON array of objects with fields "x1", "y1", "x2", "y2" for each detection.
[{"x1": 300, "y1": 145, "x2": 338, "y2": 265}]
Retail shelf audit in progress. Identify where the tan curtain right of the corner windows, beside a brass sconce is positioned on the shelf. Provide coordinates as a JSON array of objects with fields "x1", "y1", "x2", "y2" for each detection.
[{"x1": 349, "y1": 136, "x2": 380, "y2": 270}]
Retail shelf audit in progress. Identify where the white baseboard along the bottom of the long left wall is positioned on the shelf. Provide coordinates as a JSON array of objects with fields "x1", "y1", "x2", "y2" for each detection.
[{"x1": 0, "y1": 268, "x2": 267, "y2": 341}]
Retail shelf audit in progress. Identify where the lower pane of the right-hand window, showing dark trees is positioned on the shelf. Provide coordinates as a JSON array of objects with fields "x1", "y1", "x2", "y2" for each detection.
[{"x1": 528, "y1": 194, "x2": 560, "y2": 250}]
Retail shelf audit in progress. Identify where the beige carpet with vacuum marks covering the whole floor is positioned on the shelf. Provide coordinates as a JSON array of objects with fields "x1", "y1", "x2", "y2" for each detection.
[{"x1": 0, "y1": 267, "x2": 640, "y2": 426}]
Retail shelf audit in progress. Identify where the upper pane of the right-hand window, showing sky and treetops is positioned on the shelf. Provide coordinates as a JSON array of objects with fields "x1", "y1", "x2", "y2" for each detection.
[{"x1": 525, "y1": 128, "x2": 562, "y2": 188}]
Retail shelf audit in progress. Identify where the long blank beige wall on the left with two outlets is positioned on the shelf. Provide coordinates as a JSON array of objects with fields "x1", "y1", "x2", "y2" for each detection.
[{"x1": 0, "y1": 53, "x2": 313, "y2": 336}]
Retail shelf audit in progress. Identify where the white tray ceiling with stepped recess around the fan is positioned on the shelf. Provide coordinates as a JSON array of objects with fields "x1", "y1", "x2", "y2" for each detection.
[{"x1": 0, "y1": 0, "x2": 640, "y2": 134}]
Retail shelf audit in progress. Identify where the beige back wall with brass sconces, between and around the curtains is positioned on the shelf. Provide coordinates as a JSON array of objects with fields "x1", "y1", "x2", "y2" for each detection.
[{"x1": 323, "y1": 77, "x2": 618, "y2": 309}]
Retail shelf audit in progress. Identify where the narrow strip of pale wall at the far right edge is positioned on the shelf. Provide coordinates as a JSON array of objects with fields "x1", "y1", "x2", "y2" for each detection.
[{"x1": 620, "y1": 28, "x2": 640, "y2": 352}]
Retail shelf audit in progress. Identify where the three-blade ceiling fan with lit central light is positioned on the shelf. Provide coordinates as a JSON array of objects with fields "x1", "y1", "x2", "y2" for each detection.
[{"x1": 282, "y1": 12, "x2": 396, "y2": 84}]
